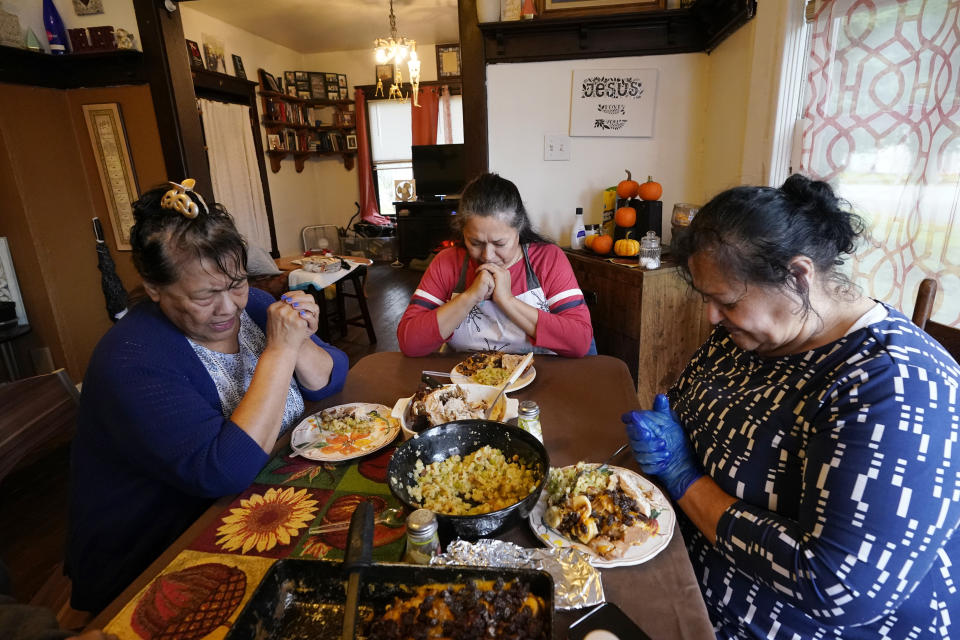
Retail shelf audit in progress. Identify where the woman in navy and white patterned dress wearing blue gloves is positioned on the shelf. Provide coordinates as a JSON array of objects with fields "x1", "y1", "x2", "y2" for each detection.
[{"x1": 623, "y1": 175, "x2": 960, "y2": 638}]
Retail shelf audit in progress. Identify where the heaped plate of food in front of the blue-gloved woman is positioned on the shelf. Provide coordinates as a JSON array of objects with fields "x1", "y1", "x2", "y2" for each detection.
[{"x1": 529, "y1": 462, "x2": 677, "y2": 568}]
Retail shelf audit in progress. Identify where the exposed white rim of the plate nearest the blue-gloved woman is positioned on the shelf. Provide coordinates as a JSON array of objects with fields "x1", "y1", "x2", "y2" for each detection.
[{"x1": 529, "y1": 465, "x2": 677, "y2": 569}]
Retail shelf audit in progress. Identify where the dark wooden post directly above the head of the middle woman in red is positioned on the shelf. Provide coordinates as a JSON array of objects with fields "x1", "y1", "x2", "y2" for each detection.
[{"x1": 458, "y1": 0, "x2": 489, "y2": 179}]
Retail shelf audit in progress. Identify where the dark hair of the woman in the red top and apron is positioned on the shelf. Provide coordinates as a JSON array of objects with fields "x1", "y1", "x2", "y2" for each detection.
[{"x1": 453, "y1": 173, "x2": 550, "y2": 244}]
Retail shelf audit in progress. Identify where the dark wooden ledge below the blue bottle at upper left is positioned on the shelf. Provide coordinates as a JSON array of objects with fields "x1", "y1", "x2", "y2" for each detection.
[{"x1": 0, "y1": 46, "x2": 147, "y2": 89}]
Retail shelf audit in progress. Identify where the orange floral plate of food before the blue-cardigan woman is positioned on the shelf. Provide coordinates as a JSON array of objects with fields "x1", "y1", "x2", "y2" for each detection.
[{"x1": 290, "y1": 402, "x2": 400, "y2": 462}]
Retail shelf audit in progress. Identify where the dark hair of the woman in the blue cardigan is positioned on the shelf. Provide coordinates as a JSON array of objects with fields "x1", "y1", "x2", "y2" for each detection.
[{"x1": 130, "y1": 184, "x2": 247, "y2": 286}]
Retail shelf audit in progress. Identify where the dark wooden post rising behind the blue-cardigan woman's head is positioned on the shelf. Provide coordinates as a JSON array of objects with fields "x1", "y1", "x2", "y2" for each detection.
[{"x1": 133, "y1": 0, "x2": 213, "y2": 202}]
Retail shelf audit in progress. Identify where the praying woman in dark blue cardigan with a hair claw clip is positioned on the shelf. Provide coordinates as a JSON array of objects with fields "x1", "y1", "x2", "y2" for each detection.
[{"x1": 66, "y1": 180, "x2": 348, "y2": 612}]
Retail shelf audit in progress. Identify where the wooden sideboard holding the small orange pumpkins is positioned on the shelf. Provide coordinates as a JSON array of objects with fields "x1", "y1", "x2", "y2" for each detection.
[{"x1": 564, "y1": 249, "x2": 710, "y2": 407}]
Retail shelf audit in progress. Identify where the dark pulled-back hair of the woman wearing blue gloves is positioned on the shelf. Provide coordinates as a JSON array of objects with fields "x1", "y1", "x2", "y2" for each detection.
[{"x1": 672, "y1": 173, "x2": 865, "y2": 311}]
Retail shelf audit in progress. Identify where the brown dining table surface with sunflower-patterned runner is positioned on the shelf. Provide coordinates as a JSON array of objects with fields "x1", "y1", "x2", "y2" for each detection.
[{"x1": 87, "y1": 352, "x2": 714, "y2": 640}]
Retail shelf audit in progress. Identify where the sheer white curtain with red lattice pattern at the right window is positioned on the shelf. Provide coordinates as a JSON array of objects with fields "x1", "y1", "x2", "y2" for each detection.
[{"x1": 801, "y1": 0, "x2": 960, "y2": 326}]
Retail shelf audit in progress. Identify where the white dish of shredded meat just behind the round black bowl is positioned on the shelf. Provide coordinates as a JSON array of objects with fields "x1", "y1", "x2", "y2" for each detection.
[{"x1": 393, "y1": 384, "x2": 519, "y2": 438}]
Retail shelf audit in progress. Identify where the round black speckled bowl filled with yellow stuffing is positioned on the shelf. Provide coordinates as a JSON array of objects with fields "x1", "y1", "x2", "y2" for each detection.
[{"x1": 387, "y1": 420, "x2": 550, "y2": 539}]
